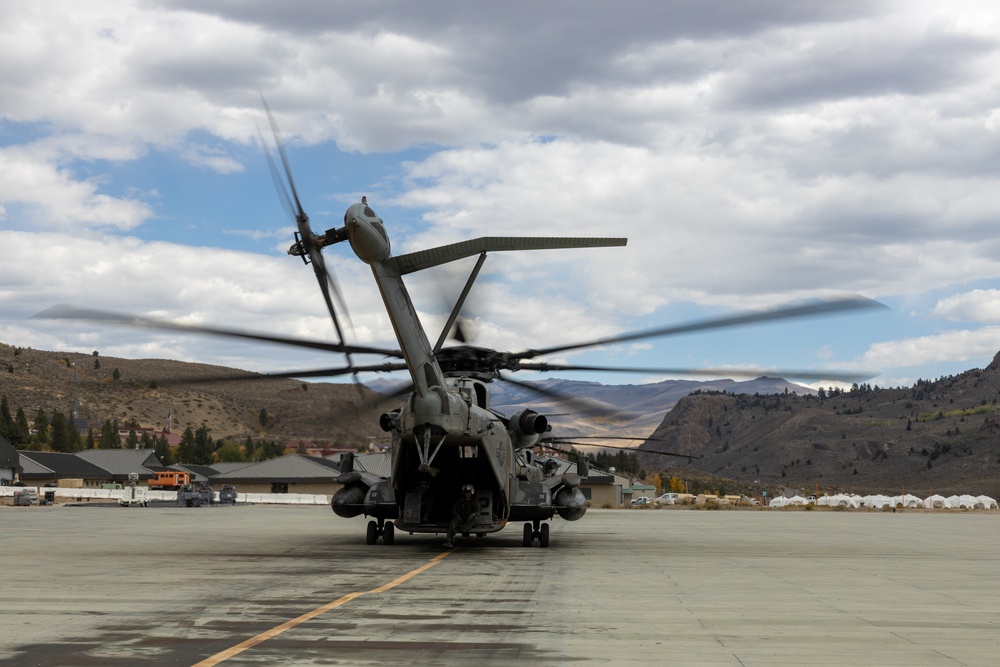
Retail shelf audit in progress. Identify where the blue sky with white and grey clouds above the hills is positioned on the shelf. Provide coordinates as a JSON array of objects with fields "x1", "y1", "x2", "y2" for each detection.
[{"x1": 0, "y1": 0, "x2": 1000, "y2": 386}]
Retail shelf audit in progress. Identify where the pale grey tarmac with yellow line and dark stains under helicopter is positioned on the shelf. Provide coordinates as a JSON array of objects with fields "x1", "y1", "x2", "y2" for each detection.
[{"x1": 0, "y1": 506, "x2": 1000, "y2": 667}]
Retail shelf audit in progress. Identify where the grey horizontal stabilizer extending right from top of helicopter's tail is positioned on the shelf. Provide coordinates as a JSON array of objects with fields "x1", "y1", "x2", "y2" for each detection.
[{"x1": 385, "y1": 236, "x2": 628, "y2": 275}]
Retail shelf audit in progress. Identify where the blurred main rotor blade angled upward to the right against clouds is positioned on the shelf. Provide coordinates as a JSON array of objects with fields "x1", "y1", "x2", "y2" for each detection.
[{"x1": 511, "y1": 297, "x2": 887, "y2": 359}]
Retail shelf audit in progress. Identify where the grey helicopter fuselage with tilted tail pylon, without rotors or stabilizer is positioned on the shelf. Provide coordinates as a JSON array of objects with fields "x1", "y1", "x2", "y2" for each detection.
[{"x1": 332, "y1": 202, "x2": 586, "y2": 535}]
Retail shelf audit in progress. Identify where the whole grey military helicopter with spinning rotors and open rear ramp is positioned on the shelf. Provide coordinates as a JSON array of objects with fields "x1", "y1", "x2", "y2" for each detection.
[{"x1": 41, "y1": 102, "x2": 880, "y2": 547}]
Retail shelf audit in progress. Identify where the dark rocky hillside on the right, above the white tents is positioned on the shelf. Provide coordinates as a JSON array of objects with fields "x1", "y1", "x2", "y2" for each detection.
[{"x1": 640, "y1": 355, "x2": 1000, "y2": 497}]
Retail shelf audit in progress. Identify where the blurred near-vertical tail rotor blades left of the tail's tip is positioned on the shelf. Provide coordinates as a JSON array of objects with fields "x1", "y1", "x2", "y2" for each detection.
[{"x1": 261, "y1": 95, "x2": 351, "y2": 354}]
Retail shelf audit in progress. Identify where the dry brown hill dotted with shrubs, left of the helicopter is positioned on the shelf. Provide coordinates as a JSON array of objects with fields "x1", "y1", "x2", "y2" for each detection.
[{"x1": 0, "y1": 344, "x2": 385, "y2": 446}]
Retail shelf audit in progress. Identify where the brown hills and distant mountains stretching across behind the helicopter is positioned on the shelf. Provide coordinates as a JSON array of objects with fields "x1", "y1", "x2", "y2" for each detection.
[{"x1": 7, "y1": 344, "x2": 1000, "y2": 497}]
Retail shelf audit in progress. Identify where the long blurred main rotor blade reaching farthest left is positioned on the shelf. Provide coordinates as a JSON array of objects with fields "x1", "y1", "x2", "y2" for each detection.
[{"x1": 32, "y1": 305, "x2": 403, "y2": 359}]
